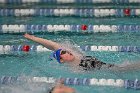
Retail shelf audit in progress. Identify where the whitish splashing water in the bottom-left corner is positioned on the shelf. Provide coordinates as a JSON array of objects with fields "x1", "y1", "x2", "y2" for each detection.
[{"x1": 0, "y1": 76, "x2": 53, "y2": 93}]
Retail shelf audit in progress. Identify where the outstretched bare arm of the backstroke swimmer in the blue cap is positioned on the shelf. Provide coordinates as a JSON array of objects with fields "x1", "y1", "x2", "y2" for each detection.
[{"x1": 24, "y1": 34, "x2": 61, "y2": 50}]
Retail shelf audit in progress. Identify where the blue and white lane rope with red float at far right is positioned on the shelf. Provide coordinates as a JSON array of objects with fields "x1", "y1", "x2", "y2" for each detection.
[{"x1": 0, "y1": 8, "x2": 140, "y2": 17}]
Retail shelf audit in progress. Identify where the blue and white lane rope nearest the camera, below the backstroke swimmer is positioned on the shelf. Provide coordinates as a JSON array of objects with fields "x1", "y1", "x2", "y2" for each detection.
[{"x1": 0, "y1": 76, "x2": 140, "y2": 90}]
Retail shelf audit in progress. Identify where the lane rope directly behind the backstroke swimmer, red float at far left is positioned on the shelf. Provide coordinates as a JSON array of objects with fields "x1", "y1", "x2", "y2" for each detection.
[{"x1": 0, "y1": 45, "x2": 140, "y2": 54}]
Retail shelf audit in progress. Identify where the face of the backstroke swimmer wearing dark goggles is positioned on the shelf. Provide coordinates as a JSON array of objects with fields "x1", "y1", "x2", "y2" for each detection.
[{"x1": 60, "y1": 50, "x2": 75, "y2": 63}]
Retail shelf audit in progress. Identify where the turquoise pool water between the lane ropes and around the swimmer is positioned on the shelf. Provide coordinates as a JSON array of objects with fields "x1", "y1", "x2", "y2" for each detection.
[{"x1": 0, "y1": 1, "x2": 140, "y2": 93}]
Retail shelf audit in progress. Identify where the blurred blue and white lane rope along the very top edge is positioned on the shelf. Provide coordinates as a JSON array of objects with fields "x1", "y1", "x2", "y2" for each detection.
[{"x1": 0, "y1": 0, "x2": 140, "y2": 4}]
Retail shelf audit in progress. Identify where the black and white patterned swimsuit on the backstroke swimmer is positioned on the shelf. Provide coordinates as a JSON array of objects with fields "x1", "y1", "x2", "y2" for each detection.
[{"x1": 79, "y1": 56, "x2": 114, "y2": 70}]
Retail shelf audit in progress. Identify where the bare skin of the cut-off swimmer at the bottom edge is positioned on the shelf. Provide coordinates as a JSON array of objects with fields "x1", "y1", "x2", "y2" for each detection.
[{"x1": 52, "y1": 85, "x2": 75, "y2": 93}]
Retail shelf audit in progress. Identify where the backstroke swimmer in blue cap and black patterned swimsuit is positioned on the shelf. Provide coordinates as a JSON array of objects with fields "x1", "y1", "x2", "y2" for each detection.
[{"x1": 24, "y1": 33, "x2": 115, "y2": 70}]
